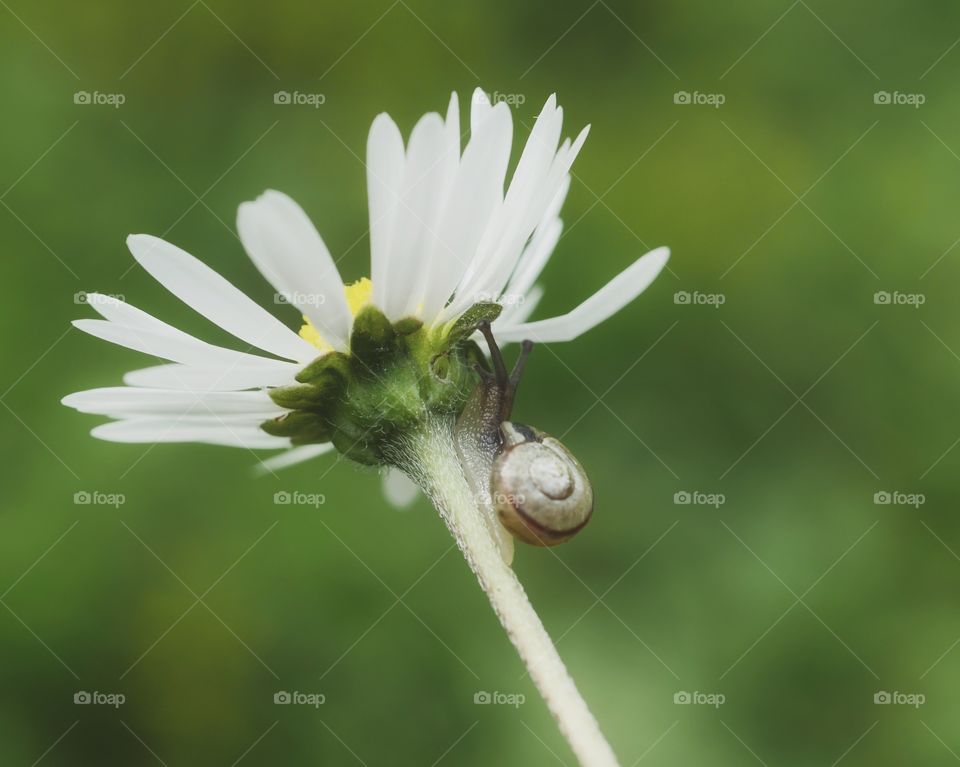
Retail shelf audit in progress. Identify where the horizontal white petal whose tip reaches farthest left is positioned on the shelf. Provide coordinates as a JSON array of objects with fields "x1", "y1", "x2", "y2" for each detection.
[{"x1": 61, "y1": 386, "x2": 287, "y2": 421}]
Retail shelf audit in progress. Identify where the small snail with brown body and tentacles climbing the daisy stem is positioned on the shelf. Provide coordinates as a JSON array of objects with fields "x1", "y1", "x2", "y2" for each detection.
[{"x1": 457, "y1": 323, "x2": 593, "y2": 556}]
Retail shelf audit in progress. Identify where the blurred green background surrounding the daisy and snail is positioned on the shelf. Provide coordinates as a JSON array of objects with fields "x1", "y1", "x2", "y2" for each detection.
[{"x1": 0, "y1": 0, "x2": 960, "y2": 767}]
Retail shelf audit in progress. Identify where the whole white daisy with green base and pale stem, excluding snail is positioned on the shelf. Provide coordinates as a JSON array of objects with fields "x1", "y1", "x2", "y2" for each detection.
[{"x1": 63, "y1": 89, "x2": 669, "y2": 764}]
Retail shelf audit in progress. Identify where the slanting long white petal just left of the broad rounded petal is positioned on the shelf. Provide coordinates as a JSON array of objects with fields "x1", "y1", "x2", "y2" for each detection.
[{"x1": 127, "y1": 234, "x2": 316, "y2": 362}]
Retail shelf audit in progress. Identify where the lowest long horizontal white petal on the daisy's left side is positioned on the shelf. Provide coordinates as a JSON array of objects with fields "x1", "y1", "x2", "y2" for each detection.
[{"x1": 90, "y1": 418, "x2": 290, "y2": 450}]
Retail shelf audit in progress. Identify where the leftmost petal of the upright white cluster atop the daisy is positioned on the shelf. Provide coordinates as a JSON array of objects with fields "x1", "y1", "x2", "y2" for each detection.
[{"x1": 367, "y1": 114, "x2": 405, "y2": 307}]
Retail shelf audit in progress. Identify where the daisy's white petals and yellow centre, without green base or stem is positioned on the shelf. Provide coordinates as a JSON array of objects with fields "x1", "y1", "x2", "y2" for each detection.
[{"x1": 63, "y1": 89, "x2": 668, "y2": 468}]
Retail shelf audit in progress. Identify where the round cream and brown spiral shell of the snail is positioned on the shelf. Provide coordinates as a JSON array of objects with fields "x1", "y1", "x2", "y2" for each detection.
[{"x1": 490, "y1": 421, "x2": 593, "y2": 546}]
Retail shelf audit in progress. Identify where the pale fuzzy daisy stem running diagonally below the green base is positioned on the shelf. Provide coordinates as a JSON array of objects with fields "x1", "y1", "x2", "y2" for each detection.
[{"x1": 399, "y1": 421, "x2": 617, "y2": 767}]
